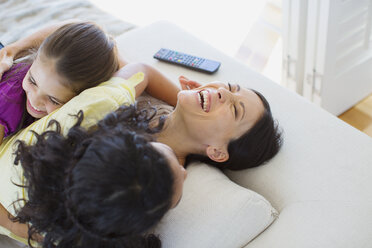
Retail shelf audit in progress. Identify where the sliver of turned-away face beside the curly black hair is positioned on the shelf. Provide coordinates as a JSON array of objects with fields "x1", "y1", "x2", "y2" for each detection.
[{"x1": 152, "y1": 142, "x2": 187, "y2": 208}]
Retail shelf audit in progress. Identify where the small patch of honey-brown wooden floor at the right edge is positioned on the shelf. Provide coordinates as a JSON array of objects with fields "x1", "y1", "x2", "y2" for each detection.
[{"x1": 339, "y1": 95, "x2": 372, "y2": 137}]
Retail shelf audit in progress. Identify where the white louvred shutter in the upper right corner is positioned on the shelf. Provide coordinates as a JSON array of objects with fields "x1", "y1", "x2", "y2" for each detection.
[{"x1": 303, "y1": 0, "x2": 372, "y2": 115}]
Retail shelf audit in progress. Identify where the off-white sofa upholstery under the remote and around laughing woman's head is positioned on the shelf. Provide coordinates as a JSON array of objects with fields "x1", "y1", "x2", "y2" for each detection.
[{"x1": 117, "y1": 22, "x2": 372, "y2": 248}]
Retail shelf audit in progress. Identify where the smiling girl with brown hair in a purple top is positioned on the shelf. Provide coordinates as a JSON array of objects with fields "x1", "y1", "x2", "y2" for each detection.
[{"x1": 0, "y1": 22, "x2": 120, "y2": 144}]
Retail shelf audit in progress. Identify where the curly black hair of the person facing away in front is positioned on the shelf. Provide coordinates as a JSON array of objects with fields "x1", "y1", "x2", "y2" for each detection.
[{"x1": 13, "y1": 106, "x2": 174, "y2": 248}]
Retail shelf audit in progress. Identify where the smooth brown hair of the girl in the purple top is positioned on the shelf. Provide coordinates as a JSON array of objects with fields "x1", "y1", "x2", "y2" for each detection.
[{"x1": 37, "y1": 22, "x2": 119, "y2": 94}]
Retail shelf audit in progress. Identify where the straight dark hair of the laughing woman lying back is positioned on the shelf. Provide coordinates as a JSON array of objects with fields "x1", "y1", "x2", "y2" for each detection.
[{"x1": 186, "y1": 90, "x2": 282, "y2": 170}]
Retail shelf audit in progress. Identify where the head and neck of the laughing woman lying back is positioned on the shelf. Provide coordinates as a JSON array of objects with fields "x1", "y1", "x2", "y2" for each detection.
[{"x1": 151, "y1": 77, "x2": 282, "y2": 170}]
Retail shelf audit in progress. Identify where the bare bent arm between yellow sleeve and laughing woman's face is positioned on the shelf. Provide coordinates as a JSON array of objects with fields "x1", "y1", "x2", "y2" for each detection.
[{"x1": 114, "y1": 63, "x2": 180, "y2": 106}]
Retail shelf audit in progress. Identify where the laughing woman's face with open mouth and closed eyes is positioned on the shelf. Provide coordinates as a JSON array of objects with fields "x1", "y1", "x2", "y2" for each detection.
[{"x1": 175, "y1": 82, "x2": 264, "y2": 162}]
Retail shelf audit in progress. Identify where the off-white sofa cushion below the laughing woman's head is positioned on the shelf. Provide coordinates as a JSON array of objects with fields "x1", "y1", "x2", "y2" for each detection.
[{"x1": 155, "y1": 163, "x2": 277, "y2": 248}]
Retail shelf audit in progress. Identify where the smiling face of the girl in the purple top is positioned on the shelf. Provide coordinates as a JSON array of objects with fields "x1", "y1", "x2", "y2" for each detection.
[{"x1": 22, "y1": 54, "x2": 76, "y2": 119}]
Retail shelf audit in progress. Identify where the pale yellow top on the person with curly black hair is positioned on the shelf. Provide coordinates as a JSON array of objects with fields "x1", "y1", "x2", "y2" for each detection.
[{"x1": 0, "y1": 72, "x2": 144, "y2": 244}]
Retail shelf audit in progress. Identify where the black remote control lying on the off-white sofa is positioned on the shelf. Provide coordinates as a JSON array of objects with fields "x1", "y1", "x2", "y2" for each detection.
[{"x1": 154, "y1": 48, "x2": 221, "y2": 73}]
